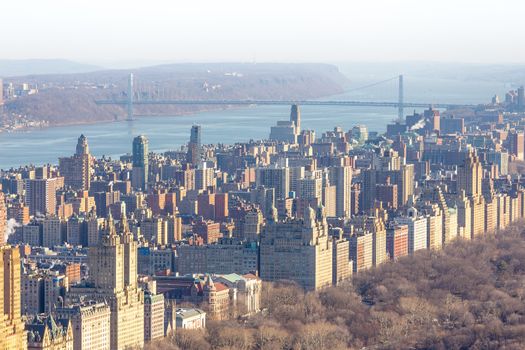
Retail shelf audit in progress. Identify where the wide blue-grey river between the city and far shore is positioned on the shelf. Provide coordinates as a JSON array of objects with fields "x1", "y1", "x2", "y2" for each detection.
[{"x1": 0, "y1": 77, "x2": 507, "y2": 169}]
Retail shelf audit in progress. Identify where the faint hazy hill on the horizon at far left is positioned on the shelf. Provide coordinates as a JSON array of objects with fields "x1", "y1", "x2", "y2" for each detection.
[{"x1": 0, "y1": 59, "x2": 102, "y2": 78}]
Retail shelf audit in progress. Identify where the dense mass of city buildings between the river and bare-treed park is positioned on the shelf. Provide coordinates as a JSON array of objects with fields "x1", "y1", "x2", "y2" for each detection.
[{"x1": 0, "y1": 76, "x2": 525, "y2": 349}]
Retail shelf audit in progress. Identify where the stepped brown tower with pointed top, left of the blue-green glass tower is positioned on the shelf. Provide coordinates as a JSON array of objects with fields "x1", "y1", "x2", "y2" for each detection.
[{"x1": 59, "y1": 135, "x2": 91, "y2": 190}]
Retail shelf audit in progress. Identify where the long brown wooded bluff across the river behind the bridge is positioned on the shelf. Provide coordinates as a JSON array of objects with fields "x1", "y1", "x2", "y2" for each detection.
[{"x1": 5, "y1": 63, "x2": 347, "y2": 125}]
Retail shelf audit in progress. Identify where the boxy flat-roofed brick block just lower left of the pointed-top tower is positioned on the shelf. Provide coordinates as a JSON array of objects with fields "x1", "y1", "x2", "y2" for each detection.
[{"x1": 25, "y1": 178, "x2": 57, "y2": 215}]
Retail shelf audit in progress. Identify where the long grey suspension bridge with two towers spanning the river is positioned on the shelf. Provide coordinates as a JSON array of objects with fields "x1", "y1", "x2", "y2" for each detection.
[{"x1": 95, "y1": 73, "x2": 474, "y2": 120}]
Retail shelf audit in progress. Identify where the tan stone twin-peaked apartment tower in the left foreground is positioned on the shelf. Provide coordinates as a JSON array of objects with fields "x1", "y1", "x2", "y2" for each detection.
[{"x1": 89, "y1": 212, "x2": 144, "y2": 349}]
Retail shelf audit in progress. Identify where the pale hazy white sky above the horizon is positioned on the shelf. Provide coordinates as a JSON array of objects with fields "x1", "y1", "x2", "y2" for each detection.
[{"x1": 0, "y1": 0, "x2": 525, "y2": 63}]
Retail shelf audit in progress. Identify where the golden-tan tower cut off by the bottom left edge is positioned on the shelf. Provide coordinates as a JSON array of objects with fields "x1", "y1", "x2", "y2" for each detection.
[{"x1": 0, "y1": 245, "x2": 27, "y2": 350}]
